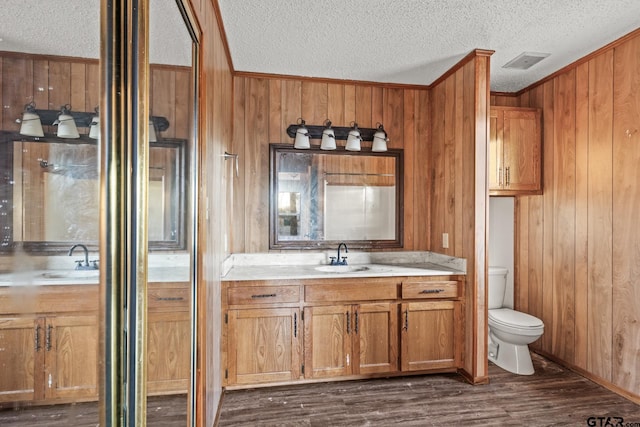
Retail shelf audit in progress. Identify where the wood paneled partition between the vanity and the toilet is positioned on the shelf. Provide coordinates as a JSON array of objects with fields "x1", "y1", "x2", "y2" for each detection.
[{"x1": 427, "y1": 51, "x2": 491, "y2": 382}]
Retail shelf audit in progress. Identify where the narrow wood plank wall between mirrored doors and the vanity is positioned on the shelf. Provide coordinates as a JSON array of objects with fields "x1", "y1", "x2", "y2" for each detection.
[{"x1": 188, "y1": 0, "x2": 237, "y2": 426}]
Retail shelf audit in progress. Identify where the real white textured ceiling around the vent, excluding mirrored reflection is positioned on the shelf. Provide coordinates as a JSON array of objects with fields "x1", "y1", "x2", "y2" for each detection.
[{"x1": 218, "y1": 0, "x2": 640, "y2": 92}]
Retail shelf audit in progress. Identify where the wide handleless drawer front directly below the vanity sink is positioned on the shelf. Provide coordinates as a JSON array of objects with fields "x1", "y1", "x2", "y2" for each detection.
[{"x1": 304, "y1": 283, "x2": 398, "y2": 302}]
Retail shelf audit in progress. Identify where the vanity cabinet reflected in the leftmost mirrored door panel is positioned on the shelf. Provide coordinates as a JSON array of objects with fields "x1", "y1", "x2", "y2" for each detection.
[{"x1": 0, "y1": 286, "x2": 98, "y2": 404}]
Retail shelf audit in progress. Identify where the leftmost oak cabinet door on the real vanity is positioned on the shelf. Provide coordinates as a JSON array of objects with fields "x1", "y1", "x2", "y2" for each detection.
[{"x1": 227, "y1": 308, "x2": 300, "y2": 385}]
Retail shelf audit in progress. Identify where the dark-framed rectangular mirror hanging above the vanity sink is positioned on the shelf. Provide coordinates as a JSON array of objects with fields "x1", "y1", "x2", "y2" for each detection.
[{"x1": 269, "y1": 144, "x2": 403, "y2": 249}]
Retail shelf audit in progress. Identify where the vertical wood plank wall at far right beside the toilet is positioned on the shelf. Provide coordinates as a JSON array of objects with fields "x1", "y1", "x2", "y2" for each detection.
[{"x1": 492, "y1": 31, "x2": 640, "y2": 400}]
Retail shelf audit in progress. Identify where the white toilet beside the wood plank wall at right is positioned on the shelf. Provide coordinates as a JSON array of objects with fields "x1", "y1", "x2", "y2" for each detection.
[{"x1": 488, "y1": 267, "x2": 544, "y2": 375}]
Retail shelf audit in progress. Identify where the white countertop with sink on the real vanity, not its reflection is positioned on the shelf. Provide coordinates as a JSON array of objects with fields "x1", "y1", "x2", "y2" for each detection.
[{"x1": 222, "y1": 251, "x2": 466, "y2": 281}]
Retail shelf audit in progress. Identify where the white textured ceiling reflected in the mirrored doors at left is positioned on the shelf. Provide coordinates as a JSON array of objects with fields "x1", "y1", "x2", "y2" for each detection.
[{"x1": 0, "y1": 0, "x2": 191, "y2": 66}]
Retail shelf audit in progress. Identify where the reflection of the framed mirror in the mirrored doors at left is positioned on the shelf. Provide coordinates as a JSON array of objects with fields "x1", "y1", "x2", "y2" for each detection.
[{"x1": 0, "y1": 138, "x2": 186, "y2": 251}]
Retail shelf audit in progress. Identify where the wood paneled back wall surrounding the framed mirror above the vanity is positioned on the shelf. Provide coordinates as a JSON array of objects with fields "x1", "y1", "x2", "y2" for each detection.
[{"x1": 229, "y1": 76, "x2": 430, "y2": 252}]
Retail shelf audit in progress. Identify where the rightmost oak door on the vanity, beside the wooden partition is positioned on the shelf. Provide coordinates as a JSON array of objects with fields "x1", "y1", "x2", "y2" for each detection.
[{"x1": 401, "y1": 301, "x2": 462, "y2": 371}]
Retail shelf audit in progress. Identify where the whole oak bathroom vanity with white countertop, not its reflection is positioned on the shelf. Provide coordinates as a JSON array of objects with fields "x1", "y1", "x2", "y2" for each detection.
[{"x1": 221, "y1": 254, "x2": 465, "y2": 389}]
